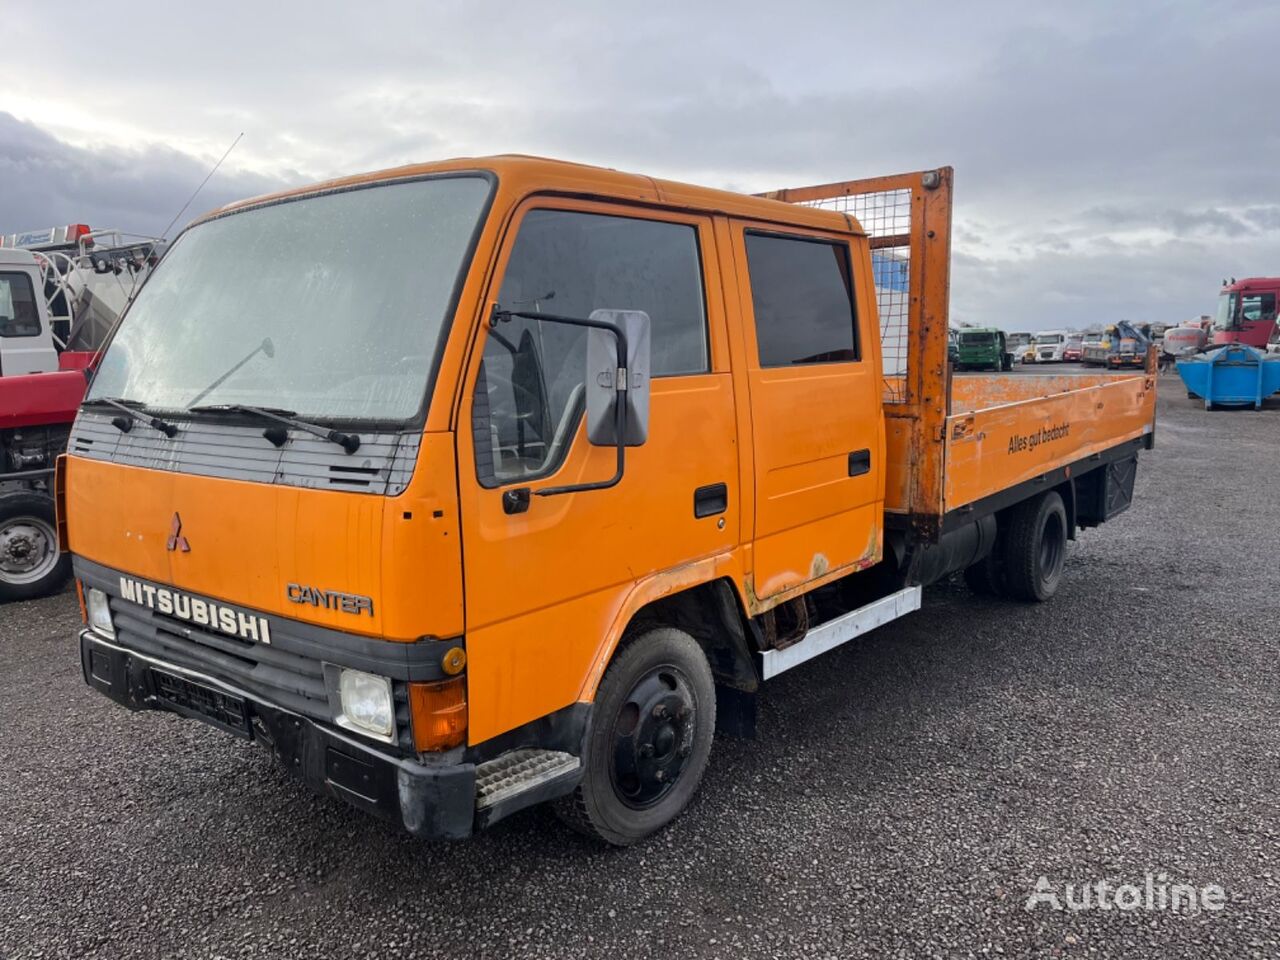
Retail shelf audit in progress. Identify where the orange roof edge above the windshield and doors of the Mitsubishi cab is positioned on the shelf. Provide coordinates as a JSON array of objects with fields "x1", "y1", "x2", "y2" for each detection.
[{"x1": 196, "y1": 154, "x2": 865, "y2": 236}]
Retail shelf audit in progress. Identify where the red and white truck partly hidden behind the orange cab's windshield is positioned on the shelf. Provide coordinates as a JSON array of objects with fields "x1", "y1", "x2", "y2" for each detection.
[{"x1": 0, "y1": 224, "x2": 160, "y2": 603}]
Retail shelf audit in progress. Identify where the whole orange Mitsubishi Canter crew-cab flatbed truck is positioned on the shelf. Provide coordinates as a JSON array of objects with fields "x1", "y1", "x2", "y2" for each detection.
[{"x1": 56, "y1": 156, "x2": 1156, "y2": 845}]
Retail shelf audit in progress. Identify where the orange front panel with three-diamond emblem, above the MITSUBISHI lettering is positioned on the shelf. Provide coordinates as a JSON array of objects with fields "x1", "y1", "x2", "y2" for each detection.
[{"x1": 67, "y1": 435, "x2": 462, "y2": 640}]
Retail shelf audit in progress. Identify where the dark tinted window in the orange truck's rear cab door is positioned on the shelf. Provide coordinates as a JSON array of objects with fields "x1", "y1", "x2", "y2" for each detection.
[{"x1": 745, "y1": 230, "x2": 859, "y2": 367}]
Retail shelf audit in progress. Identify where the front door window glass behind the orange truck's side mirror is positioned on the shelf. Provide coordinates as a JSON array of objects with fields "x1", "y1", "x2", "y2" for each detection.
[{"x1": 472, "y1": 210, "x2": 709, "y2": 486}]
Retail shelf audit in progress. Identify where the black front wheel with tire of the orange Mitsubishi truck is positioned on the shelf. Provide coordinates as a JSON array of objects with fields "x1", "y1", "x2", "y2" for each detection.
[{"x1": 556, "y1": 627, "x2": 716, "y2": 846}]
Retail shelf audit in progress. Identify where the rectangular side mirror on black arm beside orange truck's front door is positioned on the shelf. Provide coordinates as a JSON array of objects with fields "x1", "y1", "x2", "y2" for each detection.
[{"x1": 584, "y1": 310, "x2": 652, "y2": 447}]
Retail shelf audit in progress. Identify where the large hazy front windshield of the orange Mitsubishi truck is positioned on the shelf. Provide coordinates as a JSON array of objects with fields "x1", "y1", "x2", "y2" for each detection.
[{"x1": 88, "y1": 174, "x2": 490, "y2": 421}]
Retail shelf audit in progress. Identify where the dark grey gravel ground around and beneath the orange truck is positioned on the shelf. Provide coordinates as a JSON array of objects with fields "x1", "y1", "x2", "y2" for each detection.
[{"x1": 0, "y1": 378, "x2": 1280, "y2": 959}]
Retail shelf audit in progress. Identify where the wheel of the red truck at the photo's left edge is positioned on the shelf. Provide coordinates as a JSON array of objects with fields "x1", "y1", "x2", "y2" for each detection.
[{"x1": 0, "y1": 493, "x2": 72, "y2": 603}]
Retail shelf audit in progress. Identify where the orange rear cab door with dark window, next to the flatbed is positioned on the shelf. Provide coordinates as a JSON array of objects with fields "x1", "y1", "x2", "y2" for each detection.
[{"x1": 732, "y1": 221, "x2": 884, "y2": 600}]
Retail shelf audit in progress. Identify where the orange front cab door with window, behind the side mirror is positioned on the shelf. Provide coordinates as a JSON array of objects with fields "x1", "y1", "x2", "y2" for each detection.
[{"x1": 457, "y1": 197, "x2": 740, "y2": 742}]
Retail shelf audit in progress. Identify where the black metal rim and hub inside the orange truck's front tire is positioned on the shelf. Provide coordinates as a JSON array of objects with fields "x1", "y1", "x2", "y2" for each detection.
[{"x1": 613, "y1": 667, "x2": 695, "y2": 808}]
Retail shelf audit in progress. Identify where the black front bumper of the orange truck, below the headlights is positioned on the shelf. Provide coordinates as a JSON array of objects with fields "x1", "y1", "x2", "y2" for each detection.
[{"x1": 79, "y1": 630, "x2": 476, "y2": 840}]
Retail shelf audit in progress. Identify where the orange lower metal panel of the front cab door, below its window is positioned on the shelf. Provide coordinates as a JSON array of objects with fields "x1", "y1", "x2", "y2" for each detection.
[{"x1": 458, "y1": 374, "x2": 741, "y2": 742}]
